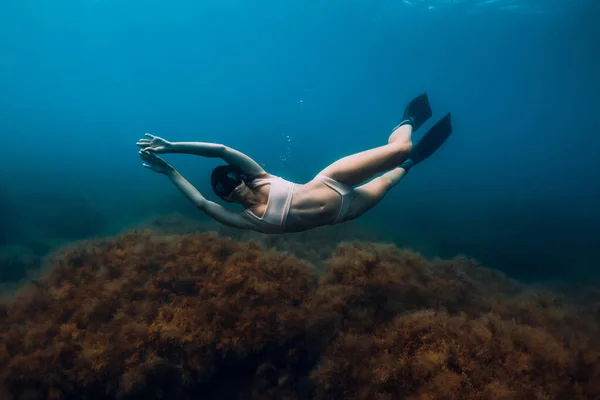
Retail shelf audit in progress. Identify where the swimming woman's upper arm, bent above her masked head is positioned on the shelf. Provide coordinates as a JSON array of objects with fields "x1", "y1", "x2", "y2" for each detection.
[{"x1": 137, "y1": 133, "x2": 266, "y2": 177}]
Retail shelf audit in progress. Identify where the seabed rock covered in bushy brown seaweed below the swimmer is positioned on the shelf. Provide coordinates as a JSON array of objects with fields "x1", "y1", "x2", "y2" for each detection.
[{"x1": 0, "y1": 232, "x2": 600, "y2": 400}]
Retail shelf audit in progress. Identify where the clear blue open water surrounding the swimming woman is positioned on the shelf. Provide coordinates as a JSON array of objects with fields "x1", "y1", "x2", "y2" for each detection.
[{"x1": 0, "y1": 0, "x2": 600, "y2": 281}]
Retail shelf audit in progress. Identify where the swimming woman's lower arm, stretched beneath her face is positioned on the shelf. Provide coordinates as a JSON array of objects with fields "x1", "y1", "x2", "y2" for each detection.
[{"x1": 140, "y1": 150, "x2": 254, "y2": 229}]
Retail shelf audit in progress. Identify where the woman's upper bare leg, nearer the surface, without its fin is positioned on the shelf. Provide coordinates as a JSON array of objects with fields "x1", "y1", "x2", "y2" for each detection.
[{"x1": 319, "y1": 124, "x2": 412, "y2": 186}]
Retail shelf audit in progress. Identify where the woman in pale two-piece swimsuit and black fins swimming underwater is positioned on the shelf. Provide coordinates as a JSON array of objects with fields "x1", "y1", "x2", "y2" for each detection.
[{"x1": 136, "y1": 93, "x2": 452, "y2": 233}]
